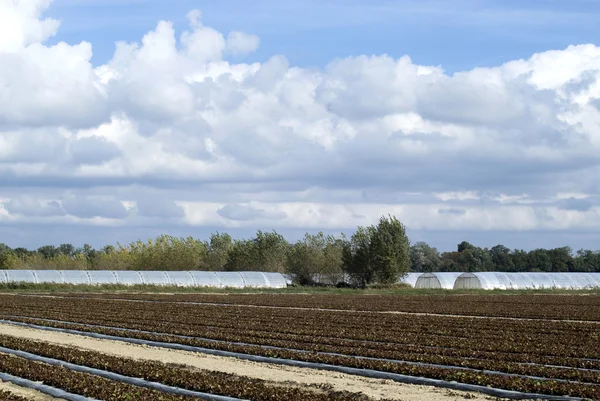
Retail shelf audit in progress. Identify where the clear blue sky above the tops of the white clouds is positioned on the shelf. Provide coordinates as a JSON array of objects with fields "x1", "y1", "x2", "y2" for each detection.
[{"x1": 48, "y1": 0, "x2": 600, "y2": 73}]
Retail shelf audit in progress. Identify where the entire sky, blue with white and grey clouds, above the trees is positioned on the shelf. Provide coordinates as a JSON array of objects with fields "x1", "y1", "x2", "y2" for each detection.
[{"x1": 0, "y1": 0, "x2": 600, "y2": 251}]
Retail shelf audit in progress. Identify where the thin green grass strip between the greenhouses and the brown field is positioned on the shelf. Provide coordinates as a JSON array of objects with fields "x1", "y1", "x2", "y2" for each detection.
[{"x1": 0, "y1": 283, "x2": 600, "y2": 295}]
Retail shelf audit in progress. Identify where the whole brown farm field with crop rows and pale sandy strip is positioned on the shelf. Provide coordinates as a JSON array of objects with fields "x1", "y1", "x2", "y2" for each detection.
[{"x1": 0, "y1": 293, "x2": 600, "y2": 400}]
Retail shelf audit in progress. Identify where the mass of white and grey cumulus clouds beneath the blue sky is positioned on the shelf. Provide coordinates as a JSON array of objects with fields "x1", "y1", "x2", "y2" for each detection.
[{"x1": 0, "y1": 0, "x2": 600, "y2": 247}]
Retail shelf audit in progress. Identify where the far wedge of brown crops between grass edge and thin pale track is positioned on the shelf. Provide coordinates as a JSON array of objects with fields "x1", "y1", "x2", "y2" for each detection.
[{"x1": 44, "y1": 294, "x2": 600, "y2": 321}]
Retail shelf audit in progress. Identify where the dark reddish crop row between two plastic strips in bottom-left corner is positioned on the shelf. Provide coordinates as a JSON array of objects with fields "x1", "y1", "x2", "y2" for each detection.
[{"x1": 0, "y1": 353, "x2": 197, "y2": 401}]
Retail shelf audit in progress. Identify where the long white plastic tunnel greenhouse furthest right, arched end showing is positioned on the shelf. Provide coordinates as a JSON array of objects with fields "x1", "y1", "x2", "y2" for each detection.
[{"x1": 454, "y1": 272, "x2": 600, "y2": 290}]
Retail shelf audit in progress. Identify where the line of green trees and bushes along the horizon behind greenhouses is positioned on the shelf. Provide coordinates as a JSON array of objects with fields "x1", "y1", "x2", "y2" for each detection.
[{"x1": 0, "y1": 216, "x2": 600, "y2": 286}]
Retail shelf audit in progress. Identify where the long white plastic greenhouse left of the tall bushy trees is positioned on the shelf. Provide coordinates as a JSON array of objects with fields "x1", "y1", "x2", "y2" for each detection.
[{"x1": 0, "y1": 270, "x2": 288, "y2": 288}]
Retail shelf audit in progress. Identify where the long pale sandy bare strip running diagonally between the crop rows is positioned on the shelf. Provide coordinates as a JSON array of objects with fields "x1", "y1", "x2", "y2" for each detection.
[{"x1": 0, "y1": 324, "x2": 508, "y2": 401}]
